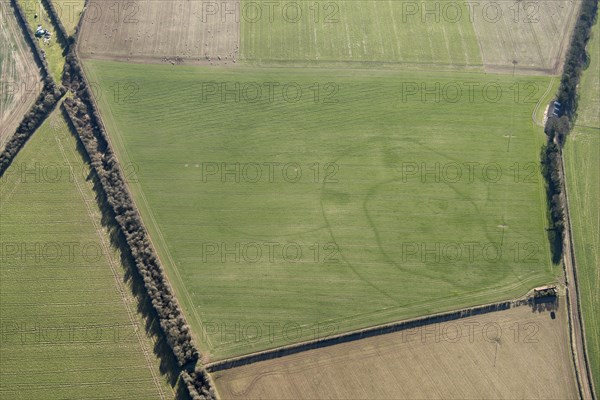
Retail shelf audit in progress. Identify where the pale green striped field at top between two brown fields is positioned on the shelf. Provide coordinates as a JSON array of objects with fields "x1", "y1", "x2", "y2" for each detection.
[{"x1": 240, "y1": 0, "x2": 482, "y2": 69}]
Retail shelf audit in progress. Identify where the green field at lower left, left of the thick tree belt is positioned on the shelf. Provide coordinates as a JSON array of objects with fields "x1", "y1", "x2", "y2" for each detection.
[{"x1": 0, "y1": 108, "x2": 173, "y2": 400}]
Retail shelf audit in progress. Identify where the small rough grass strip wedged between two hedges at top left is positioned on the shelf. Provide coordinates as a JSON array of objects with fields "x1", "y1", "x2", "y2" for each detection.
[{"x1": 18, "y1": 0, "x2": 65, "y2": 83}]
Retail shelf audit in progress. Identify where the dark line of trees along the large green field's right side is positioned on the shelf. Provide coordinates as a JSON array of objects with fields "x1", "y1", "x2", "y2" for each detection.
[{"x1": 541, "y1": 0, "x2": 598, "y2": 263}]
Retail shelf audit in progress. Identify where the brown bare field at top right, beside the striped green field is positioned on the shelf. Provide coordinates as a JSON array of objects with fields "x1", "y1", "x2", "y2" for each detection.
[{"x1": 471, "y1": 0, "x2": 579, "y2": 74}]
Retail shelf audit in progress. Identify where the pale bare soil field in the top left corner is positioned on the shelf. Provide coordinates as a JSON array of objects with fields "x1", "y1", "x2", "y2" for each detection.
[{"x1": 0, "y1": 1, "x2": 42, "y2": 148}]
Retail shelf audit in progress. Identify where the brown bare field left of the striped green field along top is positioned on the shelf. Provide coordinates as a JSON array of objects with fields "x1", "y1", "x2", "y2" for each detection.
[{"x1": 78, "y1": 0, "x2": 240, "y2": 64}]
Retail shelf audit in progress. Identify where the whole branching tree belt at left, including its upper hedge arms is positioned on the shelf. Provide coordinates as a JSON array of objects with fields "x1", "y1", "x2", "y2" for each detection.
[{"x1": 0, "y1": 0, "x2": 215, "y2": 400}]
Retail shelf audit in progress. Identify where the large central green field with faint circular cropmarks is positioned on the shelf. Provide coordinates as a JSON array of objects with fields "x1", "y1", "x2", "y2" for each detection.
[{"x1": 86, "y1": 61, "x2": 561, "y2": 359}]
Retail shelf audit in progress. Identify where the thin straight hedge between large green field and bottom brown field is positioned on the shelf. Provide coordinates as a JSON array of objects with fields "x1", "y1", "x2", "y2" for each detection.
[{"x1": 205, "y1": 295, "x2": 544, "y2": 373}]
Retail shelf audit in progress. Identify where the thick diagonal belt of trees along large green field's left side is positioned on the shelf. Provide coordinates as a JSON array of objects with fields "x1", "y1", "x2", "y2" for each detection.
[{"x1": 63, "y1": 50, "x2": 214, "y2": 400}]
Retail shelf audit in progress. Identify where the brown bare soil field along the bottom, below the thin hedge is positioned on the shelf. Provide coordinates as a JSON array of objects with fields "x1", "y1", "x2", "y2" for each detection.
[{"x1": 213, "y1": 298, "x2": 578, "y2": 399}]
